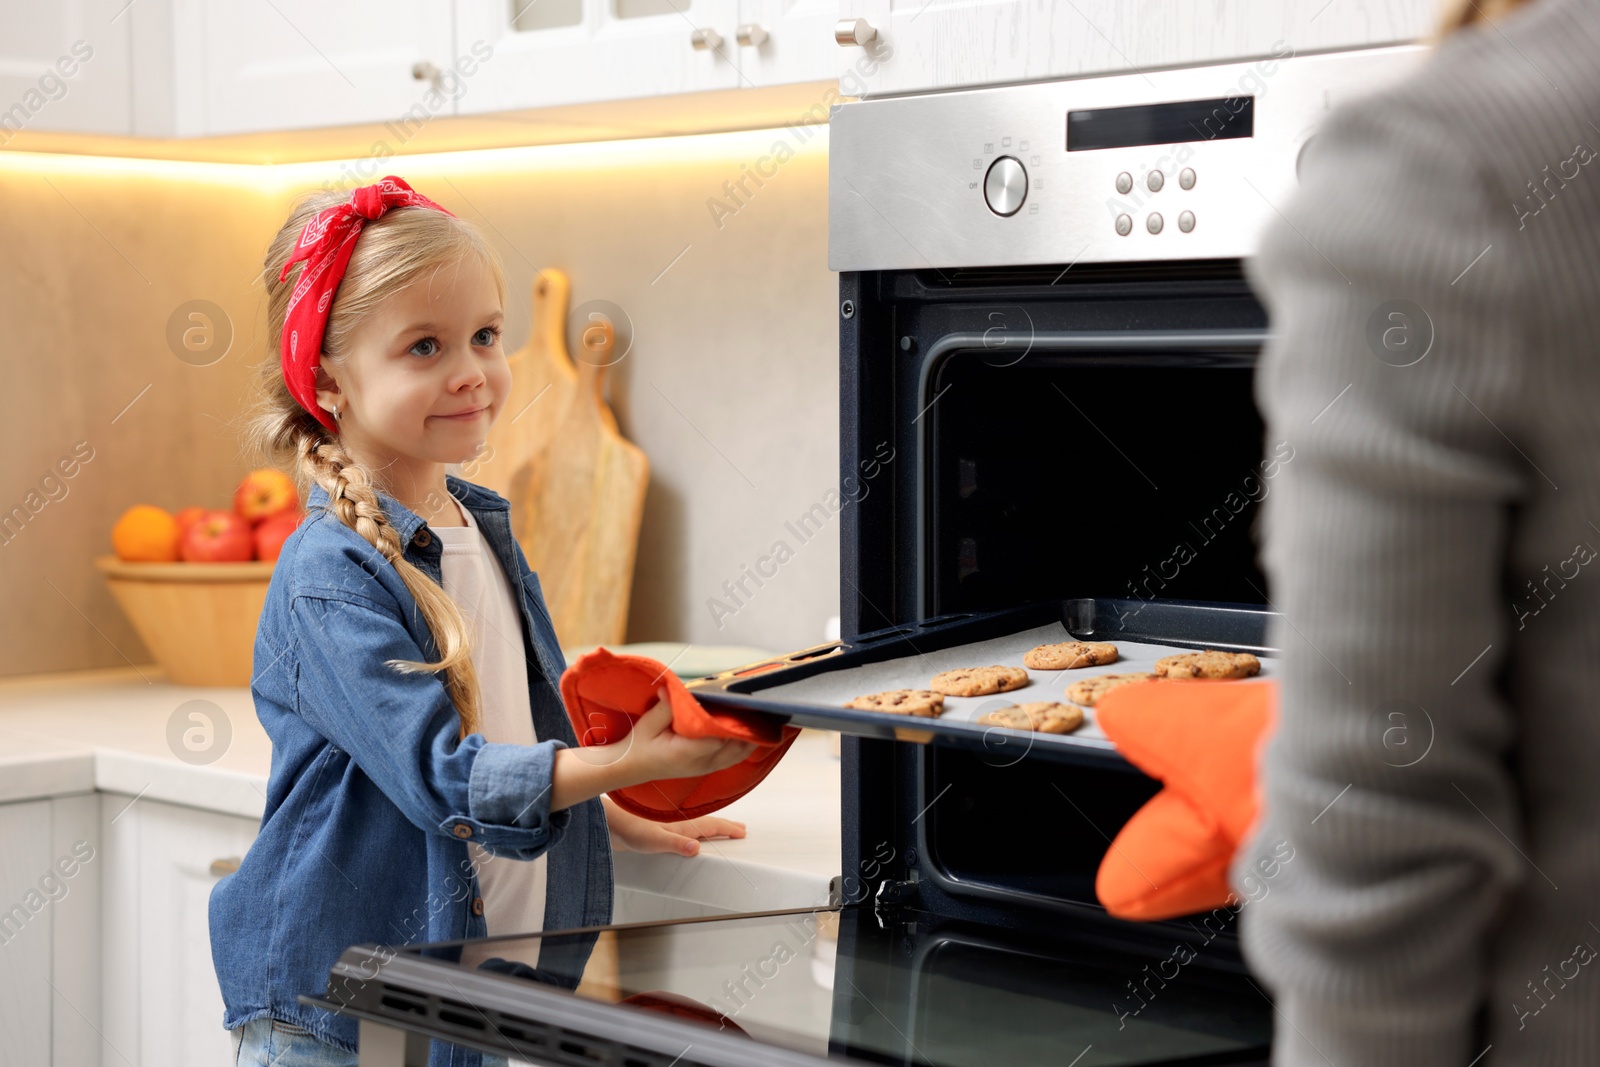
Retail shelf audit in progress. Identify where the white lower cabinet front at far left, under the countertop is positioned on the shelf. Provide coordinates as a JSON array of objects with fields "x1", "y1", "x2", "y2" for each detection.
[{"x1": 0, "y1": 795, "x2": 101, "y2": 1067}]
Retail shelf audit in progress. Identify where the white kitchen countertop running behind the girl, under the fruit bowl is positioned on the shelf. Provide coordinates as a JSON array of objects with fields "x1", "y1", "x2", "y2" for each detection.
[{"x1": 0, "y1": 667, "x2": 840, "y2": 921}]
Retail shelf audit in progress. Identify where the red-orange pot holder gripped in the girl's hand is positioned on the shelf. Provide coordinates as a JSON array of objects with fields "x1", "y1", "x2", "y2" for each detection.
[{"x1": 562, "y1": 648, "x2": 800, "y2": 822}]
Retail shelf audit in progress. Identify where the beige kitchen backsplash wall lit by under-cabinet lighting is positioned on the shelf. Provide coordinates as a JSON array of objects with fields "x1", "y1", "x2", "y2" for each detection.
[{"x1": 0, "y1": 128, "x2": 850, "y2": 675}]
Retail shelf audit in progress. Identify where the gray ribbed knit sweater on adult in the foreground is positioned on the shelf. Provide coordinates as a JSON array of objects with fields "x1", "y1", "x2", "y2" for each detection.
[{"x1": 1232, "y1": 0, "x2": 1600, "y2": 1067}]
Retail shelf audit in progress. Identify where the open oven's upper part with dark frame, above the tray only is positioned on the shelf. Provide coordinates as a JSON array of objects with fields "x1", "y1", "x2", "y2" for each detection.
[{"x1": 840, "y1": 261, "x2": 1267, "y2": 635}]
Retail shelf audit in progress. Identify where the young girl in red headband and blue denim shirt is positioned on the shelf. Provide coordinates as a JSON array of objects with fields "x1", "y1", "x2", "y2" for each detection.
[{"x1": 210, "y1": 176, "x2": 752, "y2": 1067}]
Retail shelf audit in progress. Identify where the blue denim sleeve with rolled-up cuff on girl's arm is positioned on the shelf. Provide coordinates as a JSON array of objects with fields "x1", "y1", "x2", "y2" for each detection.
[{"x1": 290, "y1": 595, "x2": 571, "y2": 859}]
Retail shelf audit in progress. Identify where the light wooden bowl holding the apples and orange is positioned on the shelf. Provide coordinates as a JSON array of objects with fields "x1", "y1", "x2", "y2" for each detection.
[{"x1": 94, "y1": 555, "x2": 274, "y2": 688}]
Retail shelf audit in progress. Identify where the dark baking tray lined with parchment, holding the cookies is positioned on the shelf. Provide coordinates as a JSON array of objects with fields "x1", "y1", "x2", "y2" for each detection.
[{"x1": 688, "y1": 598, "x2": 1277, "y2": 766}]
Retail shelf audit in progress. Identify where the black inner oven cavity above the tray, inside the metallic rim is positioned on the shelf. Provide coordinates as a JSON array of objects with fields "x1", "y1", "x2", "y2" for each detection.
[{"x1": 926, "y1": 349, "x2": 1270, "y2": 614}]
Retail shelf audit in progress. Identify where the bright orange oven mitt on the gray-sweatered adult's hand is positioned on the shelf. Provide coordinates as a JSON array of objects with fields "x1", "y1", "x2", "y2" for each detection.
[{"x1": 1094, "y1": 680, "x2": 1278, "y2": 920}]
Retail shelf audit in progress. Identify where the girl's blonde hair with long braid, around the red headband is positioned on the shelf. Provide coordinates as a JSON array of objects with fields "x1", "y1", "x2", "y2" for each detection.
[{"x1": 245, "y1": 190, "x2": 506, "y2": 737}]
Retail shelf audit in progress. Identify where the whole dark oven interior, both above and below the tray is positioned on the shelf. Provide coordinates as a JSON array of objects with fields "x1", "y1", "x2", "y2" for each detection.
[{"x1": 840, "y1": 261, "x2": 1273, "y2": 941}]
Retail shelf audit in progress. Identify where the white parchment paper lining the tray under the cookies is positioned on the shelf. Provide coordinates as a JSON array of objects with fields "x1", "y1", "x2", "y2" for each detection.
[{"x1": 752, "y1": 622, "x2": 1274, "y2": 739}]
